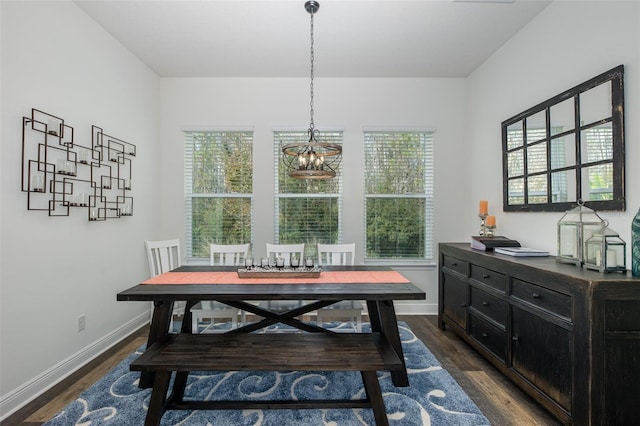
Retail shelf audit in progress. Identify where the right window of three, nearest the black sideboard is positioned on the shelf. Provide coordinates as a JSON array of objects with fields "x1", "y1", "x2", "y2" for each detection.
[{"x1": 364, "y1": 131, "x2": 433, "y2": 260}]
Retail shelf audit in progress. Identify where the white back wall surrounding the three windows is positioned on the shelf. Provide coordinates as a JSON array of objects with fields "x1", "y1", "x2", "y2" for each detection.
[{"x1": 160, "y1": 78, "x2": 468, "y2": 313}]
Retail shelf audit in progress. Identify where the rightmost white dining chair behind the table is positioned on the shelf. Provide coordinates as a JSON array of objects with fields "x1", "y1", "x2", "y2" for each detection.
[{"x1": 317, "y1": 243, "x2": 363, "y2": 332}]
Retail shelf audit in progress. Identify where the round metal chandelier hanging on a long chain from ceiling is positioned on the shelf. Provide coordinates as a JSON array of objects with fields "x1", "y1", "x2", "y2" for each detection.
[{"x1": 282, "y1": 0, "x2": 342, "y2": 179}]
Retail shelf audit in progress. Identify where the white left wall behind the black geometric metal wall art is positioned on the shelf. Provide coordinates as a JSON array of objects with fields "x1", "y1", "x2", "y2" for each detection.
[{"x1": 0, "y1": 1, "x2": 159, "y2": 416}]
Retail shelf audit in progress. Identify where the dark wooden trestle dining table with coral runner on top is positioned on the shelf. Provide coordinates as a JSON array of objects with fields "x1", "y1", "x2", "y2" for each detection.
[{"x1": 117, "y1": 266, "x2": 425, "y2": 388}]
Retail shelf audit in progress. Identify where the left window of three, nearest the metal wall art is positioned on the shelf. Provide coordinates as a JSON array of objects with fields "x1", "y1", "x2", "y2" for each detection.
[{"x1": 184, "y1": 131, "x2": 253, "y2": 258}]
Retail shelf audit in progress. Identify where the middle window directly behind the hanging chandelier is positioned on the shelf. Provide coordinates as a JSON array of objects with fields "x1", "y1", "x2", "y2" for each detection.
[{"x1": 273, "y1": 131, "x2": 342, "y2": 258}]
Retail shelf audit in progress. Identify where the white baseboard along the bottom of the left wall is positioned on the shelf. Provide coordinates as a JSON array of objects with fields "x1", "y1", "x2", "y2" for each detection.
[{"x1": 0, "y1": 311, "x2": 149, "y2": 421}]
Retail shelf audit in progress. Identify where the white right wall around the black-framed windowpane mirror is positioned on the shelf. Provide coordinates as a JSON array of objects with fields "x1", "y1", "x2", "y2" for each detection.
[{"x1": 465, "y1": 1, "x2": 640, "y2": 256}]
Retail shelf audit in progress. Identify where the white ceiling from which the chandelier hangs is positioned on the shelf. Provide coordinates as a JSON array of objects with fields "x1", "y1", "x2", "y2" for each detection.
[{"x1": 75, "y1": 0, "x2": 549, "y2": 78}]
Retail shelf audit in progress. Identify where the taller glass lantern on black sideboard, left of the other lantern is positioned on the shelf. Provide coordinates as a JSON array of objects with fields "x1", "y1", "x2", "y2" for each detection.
[{"x1": 557, "y1": 200, "x2": 605, "y2": 266}]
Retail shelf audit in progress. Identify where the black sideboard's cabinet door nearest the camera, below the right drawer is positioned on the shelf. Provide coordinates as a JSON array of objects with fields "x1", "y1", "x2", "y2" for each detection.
[{"x1": 511, "y1": 306, "x2": 573, "y2": 412}]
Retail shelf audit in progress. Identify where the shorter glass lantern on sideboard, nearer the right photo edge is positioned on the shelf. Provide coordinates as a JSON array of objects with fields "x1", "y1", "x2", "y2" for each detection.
[{"x1": 584, "y1": 225, "x2": 627, "y2": 272}]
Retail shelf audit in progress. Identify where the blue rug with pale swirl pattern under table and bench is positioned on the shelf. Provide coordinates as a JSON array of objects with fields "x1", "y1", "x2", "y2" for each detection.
[{"x1": 45, "y1": 322, "x2": 489, "y2": 426}]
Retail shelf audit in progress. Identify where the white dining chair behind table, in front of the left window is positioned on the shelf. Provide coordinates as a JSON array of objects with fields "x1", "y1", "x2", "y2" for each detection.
[{"x1": 191, "y1": 244, "x2": 249, "y2": 334}]
